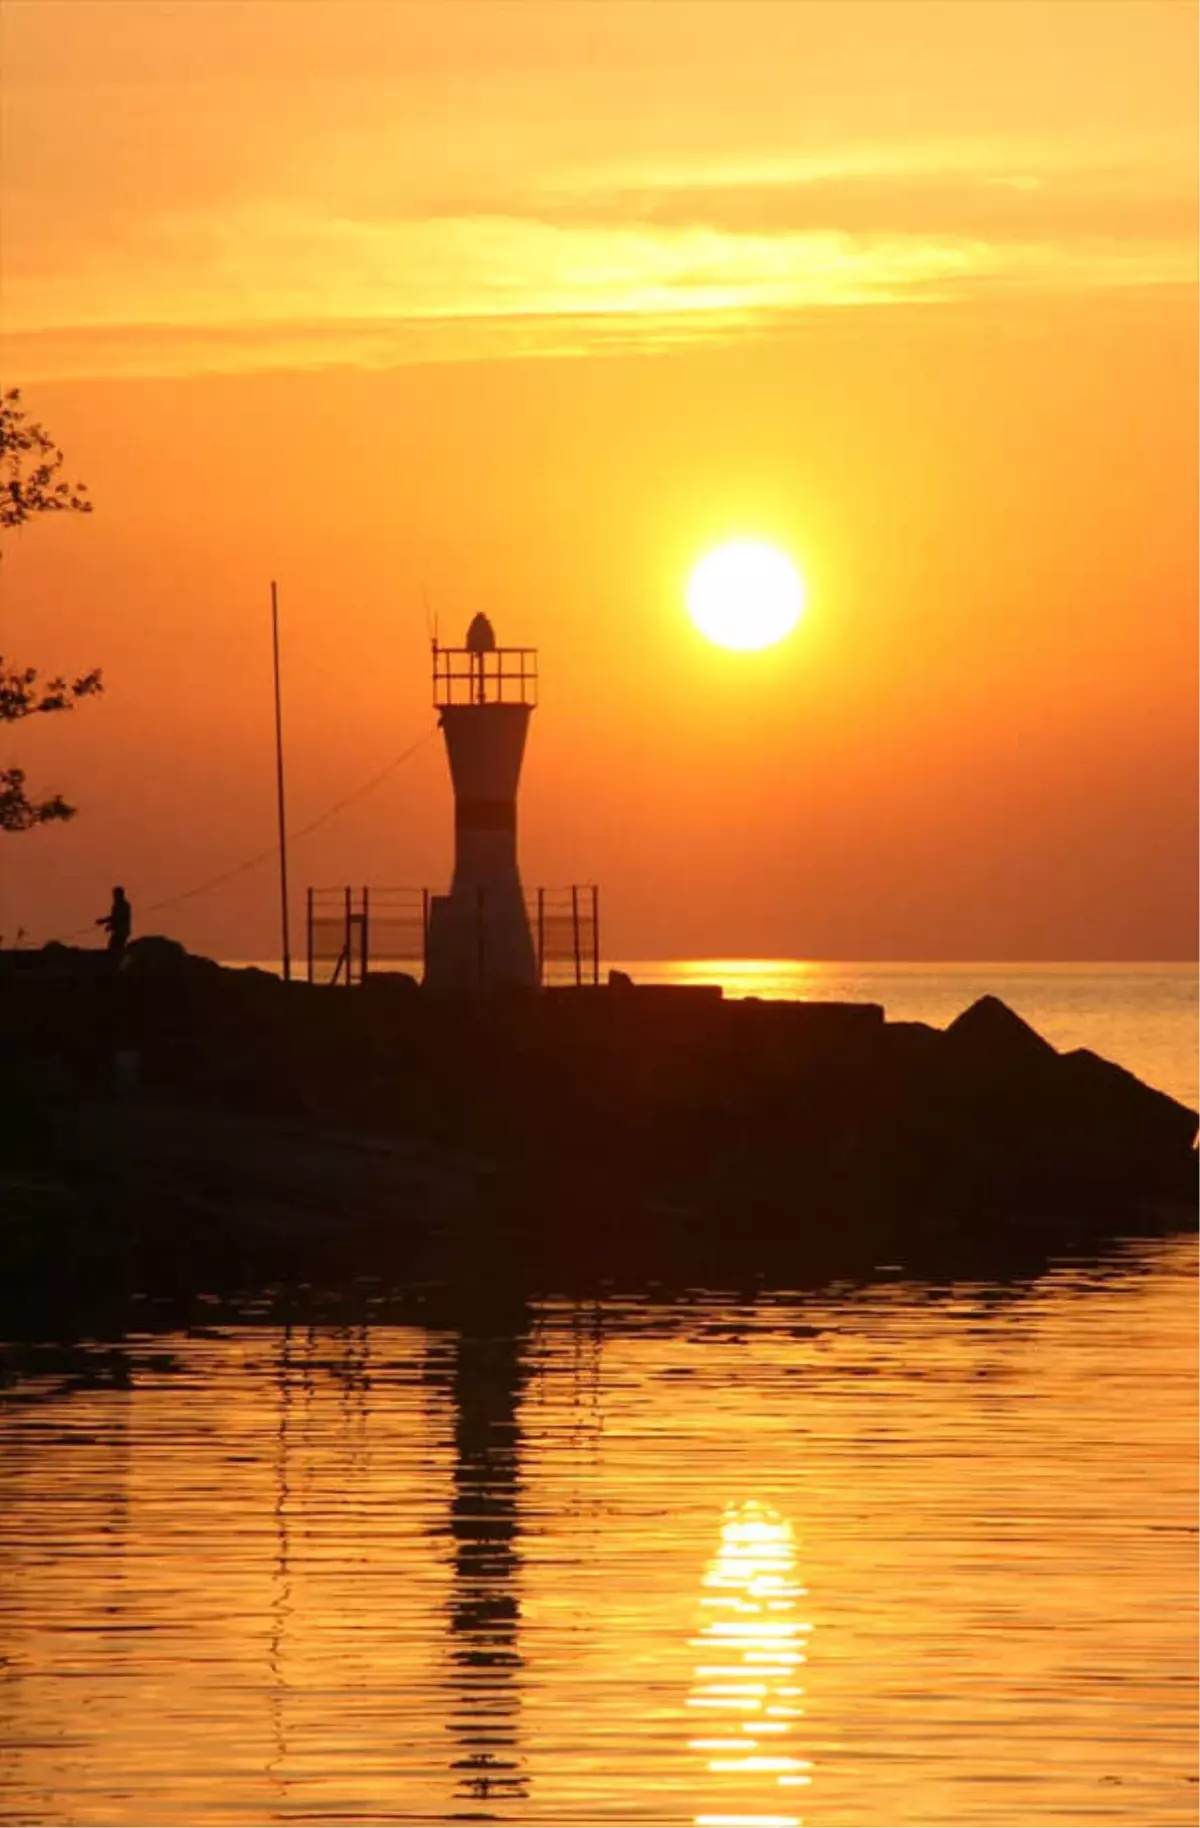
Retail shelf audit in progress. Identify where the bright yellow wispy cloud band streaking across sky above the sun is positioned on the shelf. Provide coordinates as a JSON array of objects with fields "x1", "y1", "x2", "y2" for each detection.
[{"x1": 7, "y1": 183, "x2": 1196, "y2": 378}]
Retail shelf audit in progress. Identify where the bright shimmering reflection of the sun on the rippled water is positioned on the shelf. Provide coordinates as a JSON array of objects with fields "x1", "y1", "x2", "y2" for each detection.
[{"x1": 688, "y1": 1503, "x2": 812, "y2": 1828}]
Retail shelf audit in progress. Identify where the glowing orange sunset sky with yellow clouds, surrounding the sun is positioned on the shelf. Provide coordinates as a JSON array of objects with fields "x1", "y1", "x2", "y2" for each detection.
[{"x1": 0, "y1": 0, "x2": 1200, "y2": 960}]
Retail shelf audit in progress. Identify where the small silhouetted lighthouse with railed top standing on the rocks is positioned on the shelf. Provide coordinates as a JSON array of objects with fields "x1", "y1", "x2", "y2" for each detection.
[{"x1": 424, "y1": 614, "x2": 538, "y2": 991}]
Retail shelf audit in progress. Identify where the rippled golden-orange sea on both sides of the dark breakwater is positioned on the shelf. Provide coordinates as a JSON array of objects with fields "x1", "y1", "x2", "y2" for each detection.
[{"x1": 0, "y1": 960, "x2": 1200, "y2": 1828}]
